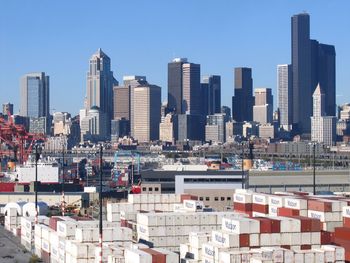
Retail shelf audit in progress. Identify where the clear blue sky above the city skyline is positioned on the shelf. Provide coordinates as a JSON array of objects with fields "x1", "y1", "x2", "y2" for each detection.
[{"x1": 0, "y1": 0, "x2": 350, "y2": 114}]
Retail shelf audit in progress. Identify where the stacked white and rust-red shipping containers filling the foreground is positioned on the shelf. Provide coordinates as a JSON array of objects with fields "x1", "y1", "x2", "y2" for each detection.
[{"x1": 3, "y1": 189, "x2": 350, "y2": 263}]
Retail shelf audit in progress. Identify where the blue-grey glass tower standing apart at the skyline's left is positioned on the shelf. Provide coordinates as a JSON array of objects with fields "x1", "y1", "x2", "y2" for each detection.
[{"x1": 20, "y1": 72, "x2": 50, "y2": 118}]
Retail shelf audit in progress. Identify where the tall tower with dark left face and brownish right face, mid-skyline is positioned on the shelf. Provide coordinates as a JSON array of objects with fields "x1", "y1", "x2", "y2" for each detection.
[{"x1": 168, "y1": 58, "x2": 201, "y2": 114}]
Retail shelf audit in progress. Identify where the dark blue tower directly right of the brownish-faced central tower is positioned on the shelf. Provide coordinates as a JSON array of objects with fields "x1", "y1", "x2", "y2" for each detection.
[{"x1": 201, "y1": 75, "x2": 221, "y2": 116}]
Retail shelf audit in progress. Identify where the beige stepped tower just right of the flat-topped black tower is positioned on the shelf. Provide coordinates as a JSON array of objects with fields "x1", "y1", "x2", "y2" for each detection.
[{"x1": 253, "y1": 88, "x2": 273, "y2": 124}]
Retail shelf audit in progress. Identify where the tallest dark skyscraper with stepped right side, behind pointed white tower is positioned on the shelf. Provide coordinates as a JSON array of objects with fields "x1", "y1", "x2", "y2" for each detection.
[{"x1": 291, "y1": 13, "x2": 336, "y2": 133}]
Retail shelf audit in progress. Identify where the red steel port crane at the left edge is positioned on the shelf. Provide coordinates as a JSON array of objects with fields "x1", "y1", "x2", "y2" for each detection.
[{"x1": 0, "y1": 112, "x2": 45, "y2": 163}]
